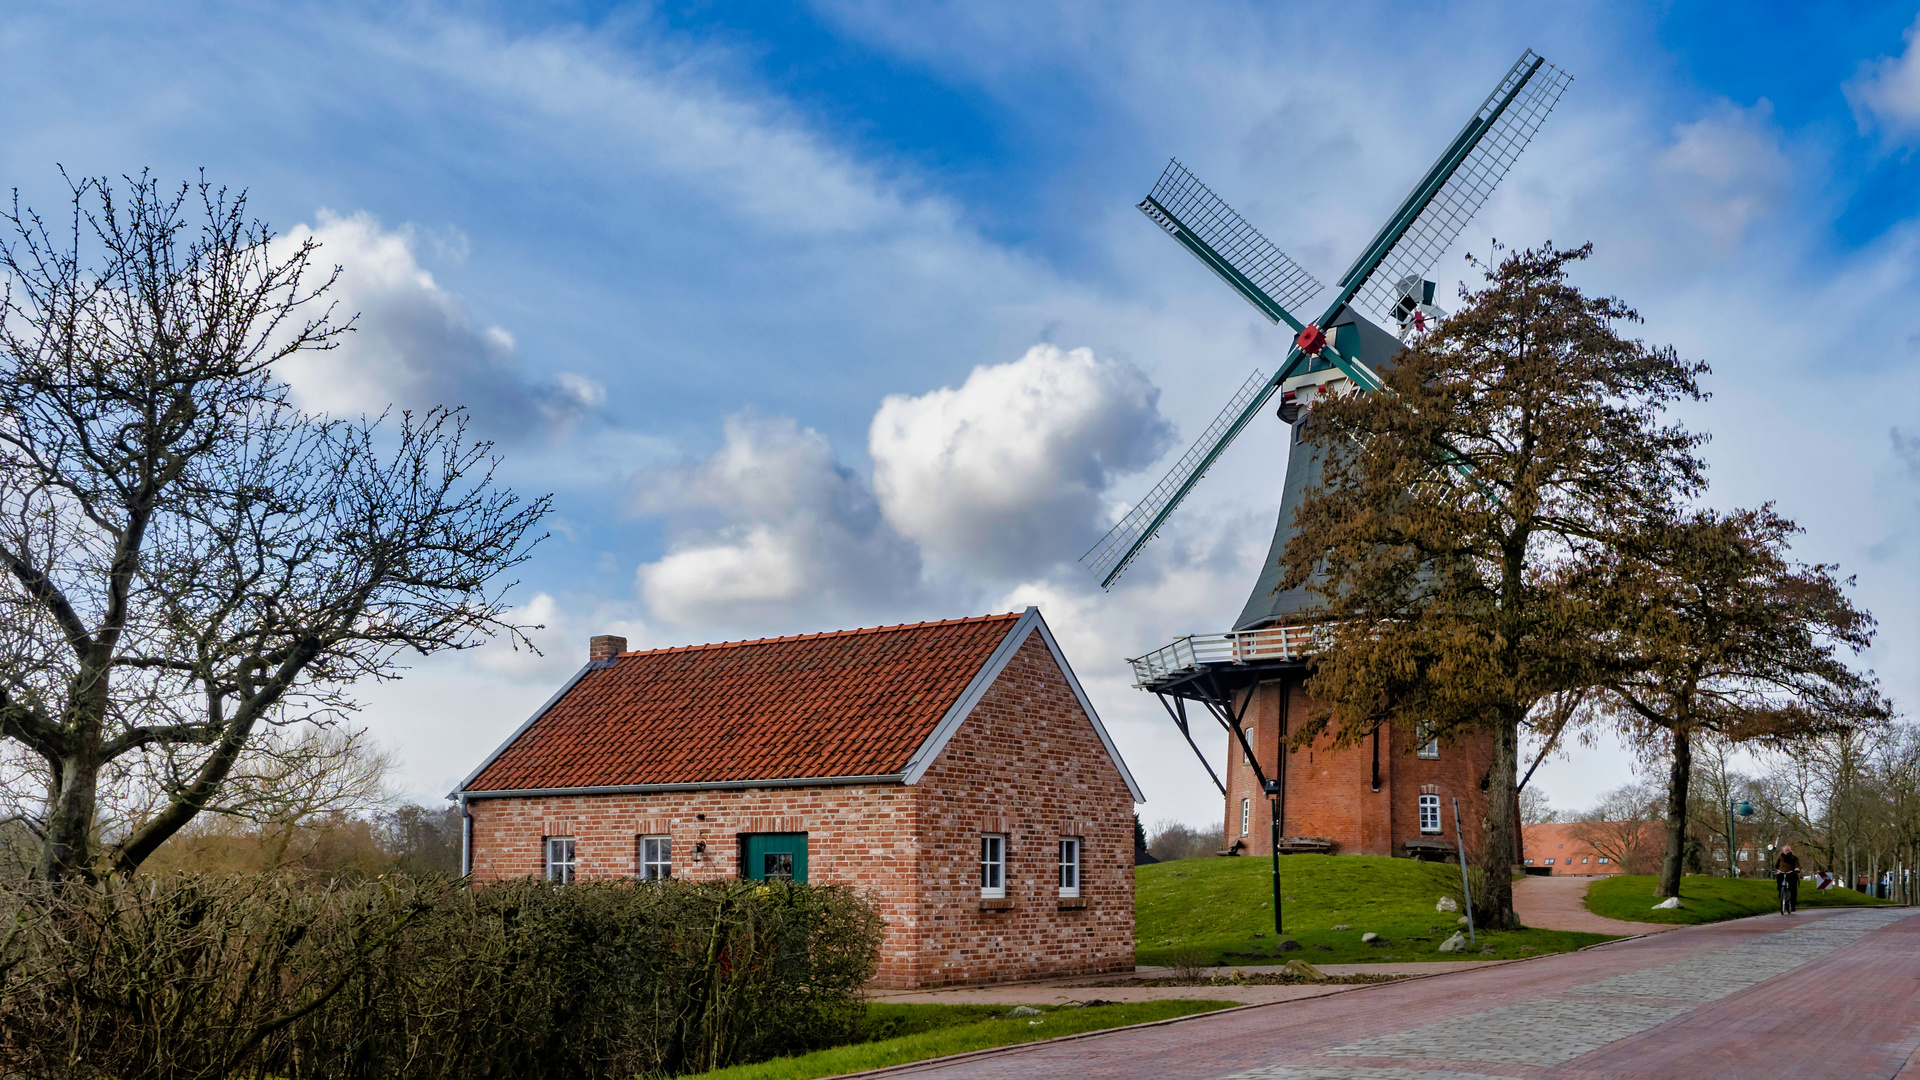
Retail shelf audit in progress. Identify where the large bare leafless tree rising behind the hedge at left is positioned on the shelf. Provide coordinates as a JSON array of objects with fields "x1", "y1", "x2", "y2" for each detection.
[{"x1": 0, "y1": 175, "x2": 549, "y2": 878}]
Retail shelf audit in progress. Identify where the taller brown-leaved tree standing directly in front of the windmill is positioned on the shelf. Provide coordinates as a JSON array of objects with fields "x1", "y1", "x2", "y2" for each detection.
[{"x1": 1283, "y1": 246, "x2": 1707, "y2": 926}]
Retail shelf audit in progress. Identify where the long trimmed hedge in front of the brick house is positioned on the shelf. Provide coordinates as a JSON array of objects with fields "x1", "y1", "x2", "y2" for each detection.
[{"x1": 0, "y1": 876, "x2": 881, "y2": 1080}]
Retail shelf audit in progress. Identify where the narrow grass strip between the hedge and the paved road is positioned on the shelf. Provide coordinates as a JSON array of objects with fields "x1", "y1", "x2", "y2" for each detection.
[{"x1": 699, "y1": 1001, "x2": 1235, "y2": 1080}]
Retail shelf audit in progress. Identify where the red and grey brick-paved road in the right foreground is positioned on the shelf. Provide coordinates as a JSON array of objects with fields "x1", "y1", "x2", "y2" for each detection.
[{"x1": 889, "y1": 909, "x2": 1920, "y2": 1080}]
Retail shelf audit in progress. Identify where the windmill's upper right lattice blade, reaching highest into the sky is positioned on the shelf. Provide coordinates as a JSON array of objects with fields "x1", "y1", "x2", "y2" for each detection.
[{"x1": 1354, "y1": 50, "x2": 1572, "y2": 325}]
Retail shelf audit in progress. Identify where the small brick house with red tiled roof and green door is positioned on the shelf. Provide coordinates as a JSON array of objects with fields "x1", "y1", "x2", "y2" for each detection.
[{"x1": 451, "y1": 607, "x2": 1140, "y2": 988}]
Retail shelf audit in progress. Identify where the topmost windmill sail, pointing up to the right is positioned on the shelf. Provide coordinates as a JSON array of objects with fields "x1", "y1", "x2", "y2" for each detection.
[{"x1": 1340, "y1": 50, "x2": 1572, "y2": 325}]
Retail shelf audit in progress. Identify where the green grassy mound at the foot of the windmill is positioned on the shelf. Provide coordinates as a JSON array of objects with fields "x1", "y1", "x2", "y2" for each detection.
[{"x1": 1133, "y1": 855, "x2": 1609, "y2": 965}]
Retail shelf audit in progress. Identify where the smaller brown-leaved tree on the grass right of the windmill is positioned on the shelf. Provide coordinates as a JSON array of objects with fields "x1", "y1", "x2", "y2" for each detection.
[{"x1": 1599, "y1": 505, "x2": 1891, "y2": 896}]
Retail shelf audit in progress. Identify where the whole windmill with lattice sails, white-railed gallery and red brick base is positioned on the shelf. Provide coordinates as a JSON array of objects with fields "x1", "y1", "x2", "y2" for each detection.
[{"x1": 1081, "y1": 50, "x2": 1571, "y2": 874}]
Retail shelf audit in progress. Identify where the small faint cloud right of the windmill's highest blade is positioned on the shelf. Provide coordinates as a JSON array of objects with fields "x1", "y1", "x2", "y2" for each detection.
[{"x1": 1655, "y1": 98, "x2": 1791, "y2": 246}]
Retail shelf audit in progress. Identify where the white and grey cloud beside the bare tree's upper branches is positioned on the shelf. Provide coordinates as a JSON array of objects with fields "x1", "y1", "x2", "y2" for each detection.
[{"x1": 278, "y1": 209, "x2": 607, "y2": 440}]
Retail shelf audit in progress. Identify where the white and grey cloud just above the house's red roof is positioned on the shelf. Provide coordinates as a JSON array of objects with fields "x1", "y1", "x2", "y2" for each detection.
[{"x1": 634, "y1": 415, "x2": 920, "y2": 626}]
